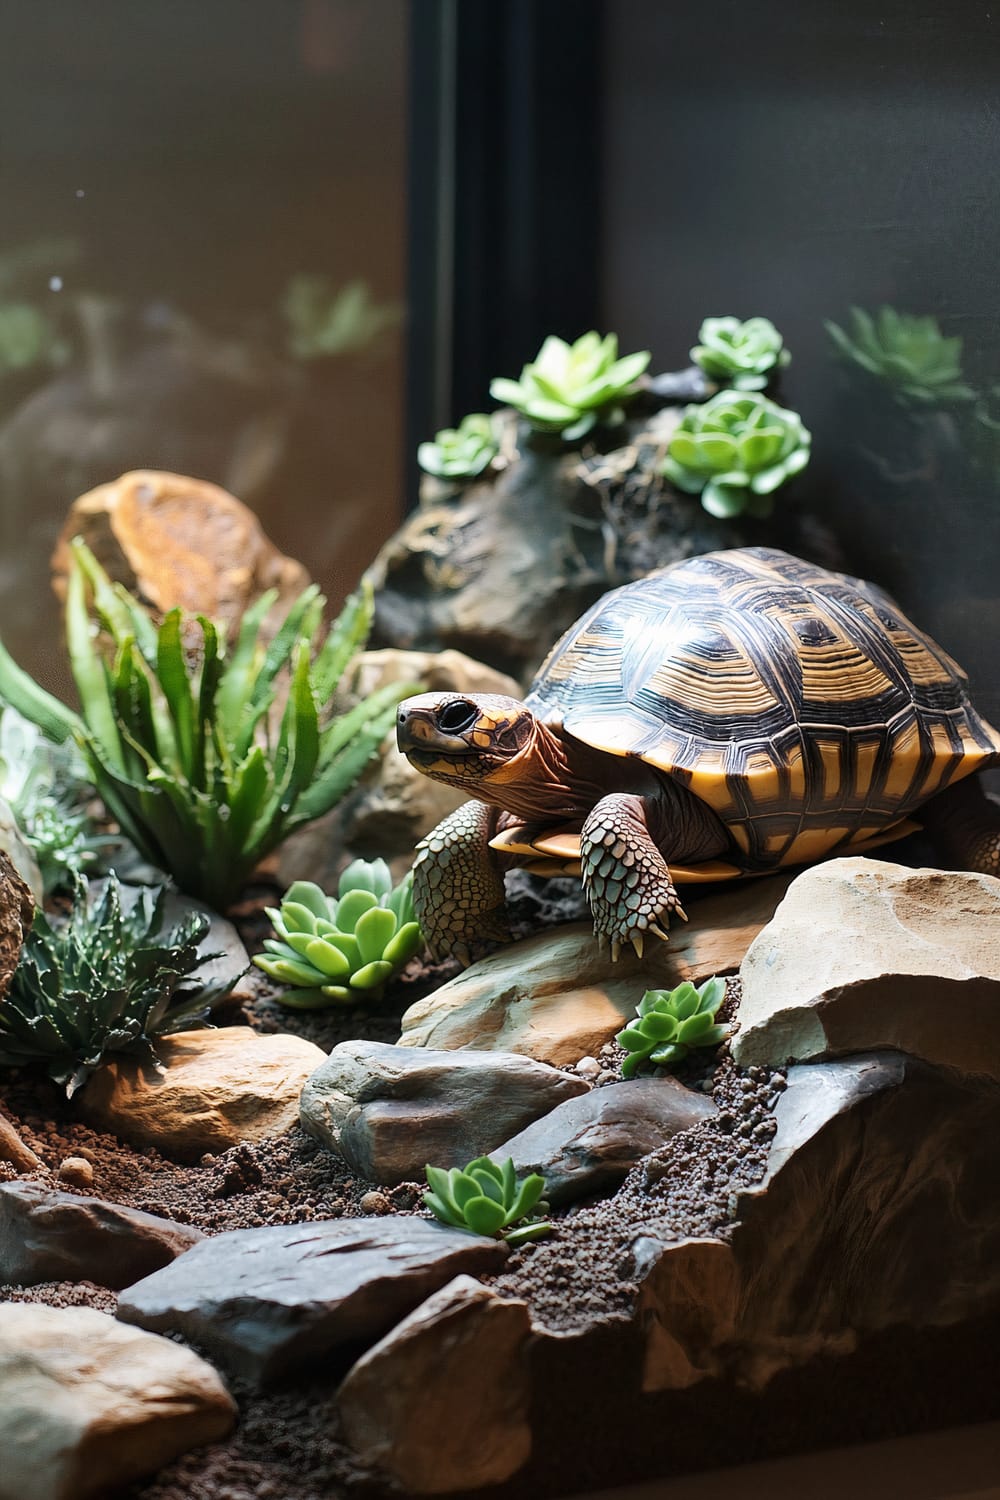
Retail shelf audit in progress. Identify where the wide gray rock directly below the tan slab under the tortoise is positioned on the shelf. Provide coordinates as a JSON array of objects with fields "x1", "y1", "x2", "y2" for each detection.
[{"x1": 300, "y1": 1041, "x2": 589, "y2": 1184}]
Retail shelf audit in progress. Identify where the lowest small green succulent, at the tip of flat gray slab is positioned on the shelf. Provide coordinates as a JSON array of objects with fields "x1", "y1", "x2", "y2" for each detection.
[{"x1": 424, "y1": 1157, "x2": 552, "y2": 1245}]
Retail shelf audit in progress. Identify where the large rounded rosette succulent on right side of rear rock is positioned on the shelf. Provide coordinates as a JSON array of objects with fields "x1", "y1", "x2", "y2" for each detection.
[{"x1": 661, "y1": 390, "x2": 813, "y2": 516}]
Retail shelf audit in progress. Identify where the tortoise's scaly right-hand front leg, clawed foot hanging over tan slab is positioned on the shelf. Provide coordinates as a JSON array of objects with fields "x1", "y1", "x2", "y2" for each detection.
[{"x1": 580, "y1": 794, "x2": 687, "y2": 960}]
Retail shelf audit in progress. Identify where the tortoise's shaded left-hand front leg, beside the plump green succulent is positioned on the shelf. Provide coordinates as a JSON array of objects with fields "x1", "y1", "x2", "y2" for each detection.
[{"x1": 414, "y1": 803, "x2": 510, "y2": 965}]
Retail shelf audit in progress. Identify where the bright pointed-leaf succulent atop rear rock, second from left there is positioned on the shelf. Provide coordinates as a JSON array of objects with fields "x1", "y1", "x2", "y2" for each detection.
[{"x1": 490, "y1": 333, "x2": 651, "y2": 443}]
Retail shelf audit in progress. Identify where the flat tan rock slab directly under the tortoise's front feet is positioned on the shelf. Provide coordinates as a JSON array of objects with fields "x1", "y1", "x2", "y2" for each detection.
[{"x1": 400, "y1": 876, "x2": 790, "y2": 1067}]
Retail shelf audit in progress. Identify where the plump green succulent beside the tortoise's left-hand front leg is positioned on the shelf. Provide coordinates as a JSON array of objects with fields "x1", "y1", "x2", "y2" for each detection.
[{"x1": 253, "y1": 860, "x2": 424, "y2": 1011}]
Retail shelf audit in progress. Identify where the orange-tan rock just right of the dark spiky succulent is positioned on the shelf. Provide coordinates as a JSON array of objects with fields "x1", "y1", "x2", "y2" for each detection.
[{"x1": 79, "y1": 1026, "x2": 327, "y2": 1161}]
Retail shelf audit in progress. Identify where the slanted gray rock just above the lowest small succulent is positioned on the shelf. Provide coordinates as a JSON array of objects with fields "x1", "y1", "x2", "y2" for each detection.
[{"x1": 490, "y1": 1079, "x2": 717, "y2": 1208}]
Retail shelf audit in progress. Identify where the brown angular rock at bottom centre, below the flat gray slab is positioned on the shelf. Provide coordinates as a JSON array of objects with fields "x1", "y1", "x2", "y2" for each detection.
[{"x1": 337, "y1": 1277, "x2": 531, "y2": 1494}]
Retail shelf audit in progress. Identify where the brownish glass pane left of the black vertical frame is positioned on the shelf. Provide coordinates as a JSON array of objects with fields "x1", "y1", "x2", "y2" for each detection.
[{"x1": 0, "y1": 0, "x2": 408, "y2": 686}]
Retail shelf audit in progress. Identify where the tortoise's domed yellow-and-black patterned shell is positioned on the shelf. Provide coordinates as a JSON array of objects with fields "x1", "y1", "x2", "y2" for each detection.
[{"x1": 528, "y1": 548, "x2": 1000, "y2": 869}]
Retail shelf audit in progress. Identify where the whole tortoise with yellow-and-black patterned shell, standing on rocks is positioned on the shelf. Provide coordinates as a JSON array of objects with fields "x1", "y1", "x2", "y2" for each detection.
[{"x1": 397, "y1": 548, "x2": 1000, "y2": 962}]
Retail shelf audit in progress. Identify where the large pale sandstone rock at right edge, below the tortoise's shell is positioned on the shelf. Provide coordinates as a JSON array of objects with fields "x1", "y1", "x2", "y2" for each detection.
[{"x1": 733, "y1": 858, "x2": 1000, "y2": 1079}]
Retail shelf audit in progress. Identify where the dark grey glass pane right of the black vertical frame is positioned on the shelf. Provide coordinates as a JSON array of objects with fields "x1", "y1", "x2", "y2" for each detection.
[{"x1": 603, "y1": 0, "x2": 1000, "y2": 723}]
